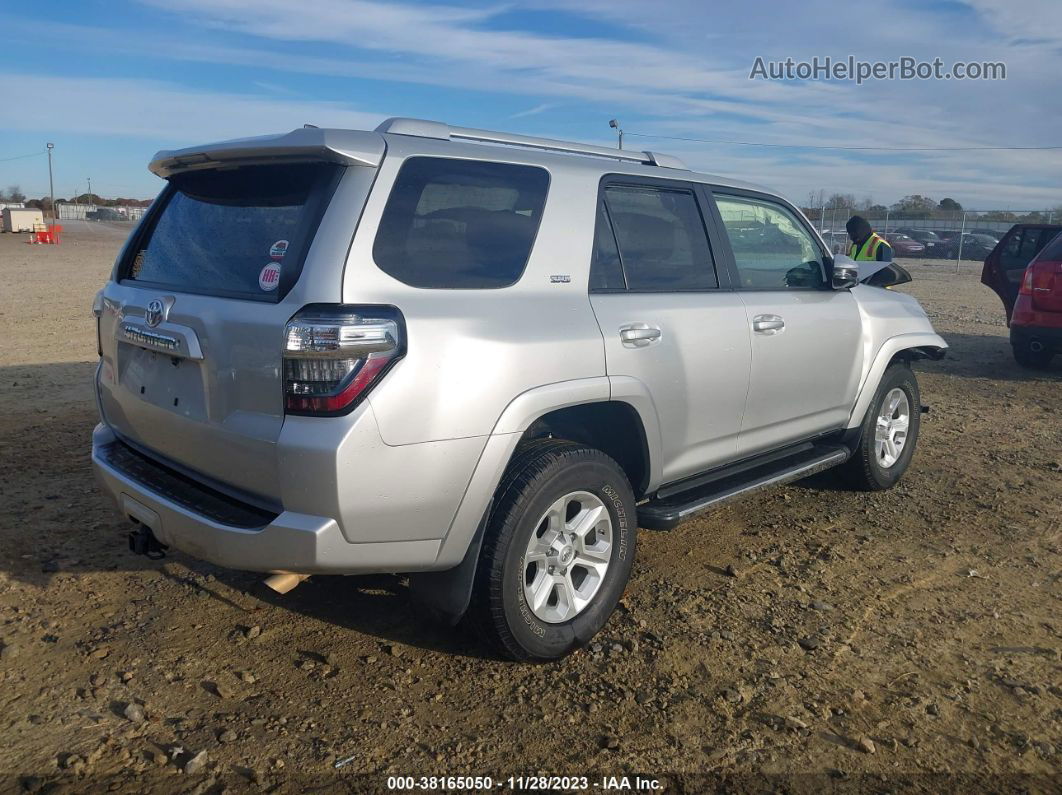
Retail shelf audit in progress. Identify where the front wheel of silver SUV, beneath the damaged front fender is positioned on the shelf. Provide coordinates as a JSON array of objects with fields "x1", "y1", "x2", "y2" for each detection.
[{"x1": 840, "y1": 362, "x2": 922, "y2": 491}]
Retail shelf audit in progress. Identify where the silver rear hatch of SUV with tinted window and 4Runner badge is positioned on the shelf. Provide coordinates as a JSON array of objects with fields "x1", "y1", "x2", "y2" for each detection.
[{"x1": 98, "y1": 154, "x2": 375, "y2": 505}]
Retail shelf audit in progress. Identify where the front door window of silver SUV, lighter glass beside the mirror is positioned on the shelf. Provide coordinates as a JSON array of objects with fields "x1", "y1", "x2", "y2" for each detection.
[{"x1": 716, "y1": 194, "x2": 825, "y2": 290}]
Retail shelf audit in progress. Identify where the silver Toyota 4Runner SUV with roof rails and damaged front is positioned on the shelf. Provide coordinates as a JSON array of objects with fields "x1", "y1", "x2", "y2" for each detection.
[{"x1": 92, "y1": 119, "x2": 946, "y2": 660}]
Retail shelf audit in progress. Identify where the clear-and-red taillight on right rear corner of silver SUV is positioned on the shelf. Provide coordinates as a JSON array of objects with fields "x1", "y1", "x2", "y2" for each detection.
[{"x1": 284, "y1": 304, "x2": 406, "y2": 416}]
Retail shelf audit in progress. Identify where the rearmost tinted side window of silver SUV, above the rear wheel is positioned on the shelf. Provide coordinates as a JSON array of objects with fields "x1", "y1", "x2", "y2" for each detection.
[{"x1": 373, "y1": 157, "x2": 549, "y2": 289}]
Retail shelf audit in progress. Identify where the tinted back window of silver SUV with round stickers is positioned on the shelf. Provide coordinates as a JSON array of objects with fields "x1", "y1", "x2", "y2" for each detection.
[{"x1": 124, "y1": 163, "x2": 341, "y2": 301}]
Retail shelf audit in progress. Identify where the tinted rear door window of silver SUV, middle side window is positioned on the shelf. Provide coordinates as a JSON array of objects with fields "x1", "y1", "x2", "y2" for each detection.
[{"x1": 604, "y1": 186, "x2": 719, "y2": 292}]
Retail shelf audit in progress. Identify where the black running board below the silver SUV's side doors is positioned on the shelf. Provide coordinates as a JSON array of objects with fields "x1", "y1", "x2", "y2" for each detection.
[{"x1": 638, "y1": 445, "x2": 851, "y2": 530}]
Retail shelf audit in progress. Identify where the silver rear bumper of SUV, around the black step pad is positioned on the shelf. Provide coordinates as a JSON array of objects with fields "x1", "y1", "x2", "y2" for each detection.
[{"x1": 92, "y1": 424, "x2": 441, "y2": 574}]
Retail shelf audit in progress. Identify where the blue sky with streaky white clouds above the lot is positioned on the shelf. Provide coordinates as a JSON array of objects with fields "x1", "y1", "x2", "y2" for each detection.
[{"x1": 0, "y1": 0, "x2": 1062, "y2": 209}]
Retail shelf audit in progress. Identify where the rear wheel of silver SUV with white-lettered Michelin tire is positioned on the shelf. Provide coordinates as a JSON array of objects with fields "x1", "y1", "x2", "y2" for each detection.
[{"x1": 468, "y1": 439, "x2": 637, "y2": 661}]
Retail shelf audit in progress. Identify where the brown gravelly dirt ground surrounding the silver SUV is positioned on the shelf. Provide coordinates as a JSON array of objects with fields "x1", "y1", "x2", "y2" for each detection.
[{"x1": 0, "y1": 223, "x2": 1062, "y2": 792}]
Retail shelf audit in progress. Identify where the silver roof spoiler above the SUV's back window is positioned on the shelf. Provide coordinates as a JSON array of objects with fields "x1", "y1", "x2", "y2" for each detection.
[{"x1": 148, "y1": 127, "x2": 386, "y2": 179}]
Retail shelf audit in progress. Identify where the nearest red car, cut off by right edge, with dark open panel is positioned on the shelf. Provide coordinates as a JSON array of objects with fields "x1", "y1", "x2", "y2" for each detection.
[{"x1": 981, "y1": 224, "x2": 1062, "y2": 369}]
